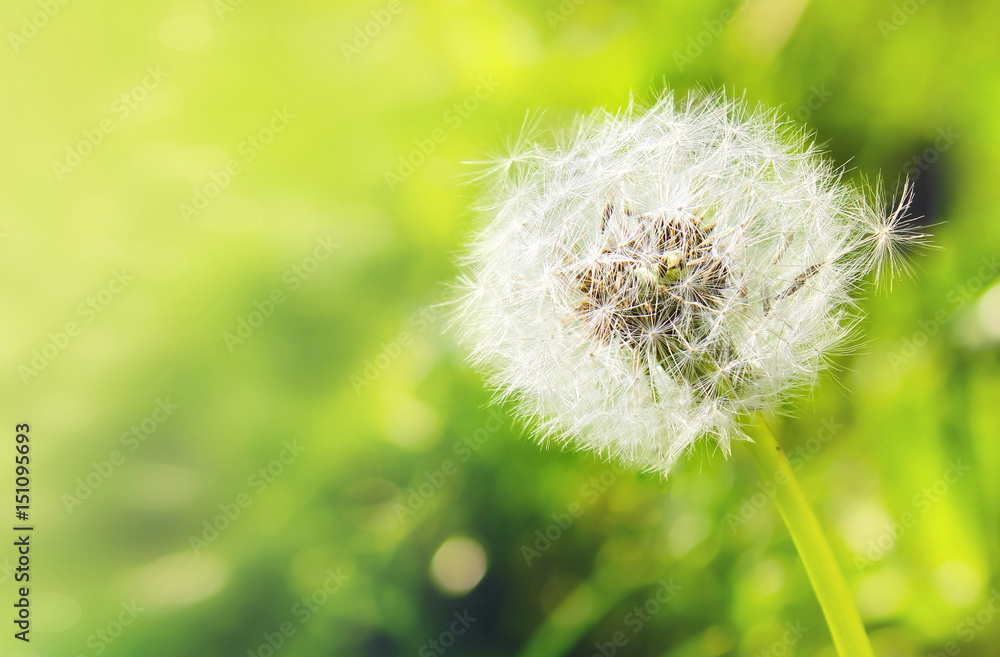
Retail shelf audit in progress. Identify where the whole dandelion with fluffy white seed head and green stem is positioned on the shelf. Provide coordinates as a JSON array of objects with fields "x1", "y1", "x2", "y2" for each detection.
[{"x1": 455, "y1": 89, "x2": 922, "y2": 657}]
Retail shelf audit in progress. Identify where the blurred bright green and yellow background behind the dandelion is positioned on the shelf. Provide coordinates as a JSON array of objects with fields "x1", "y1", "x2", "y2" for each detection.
[{"x1": 0, "y1": 0, "x2": 1000, "y2": 657}]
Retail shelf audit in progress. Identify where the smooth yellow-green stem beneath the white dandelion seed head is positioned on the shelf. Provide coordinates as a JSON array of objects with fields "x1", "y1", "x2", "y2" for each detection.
[{"x1": 747, "y1": 416, "x2": 875, "y2": 657}]
